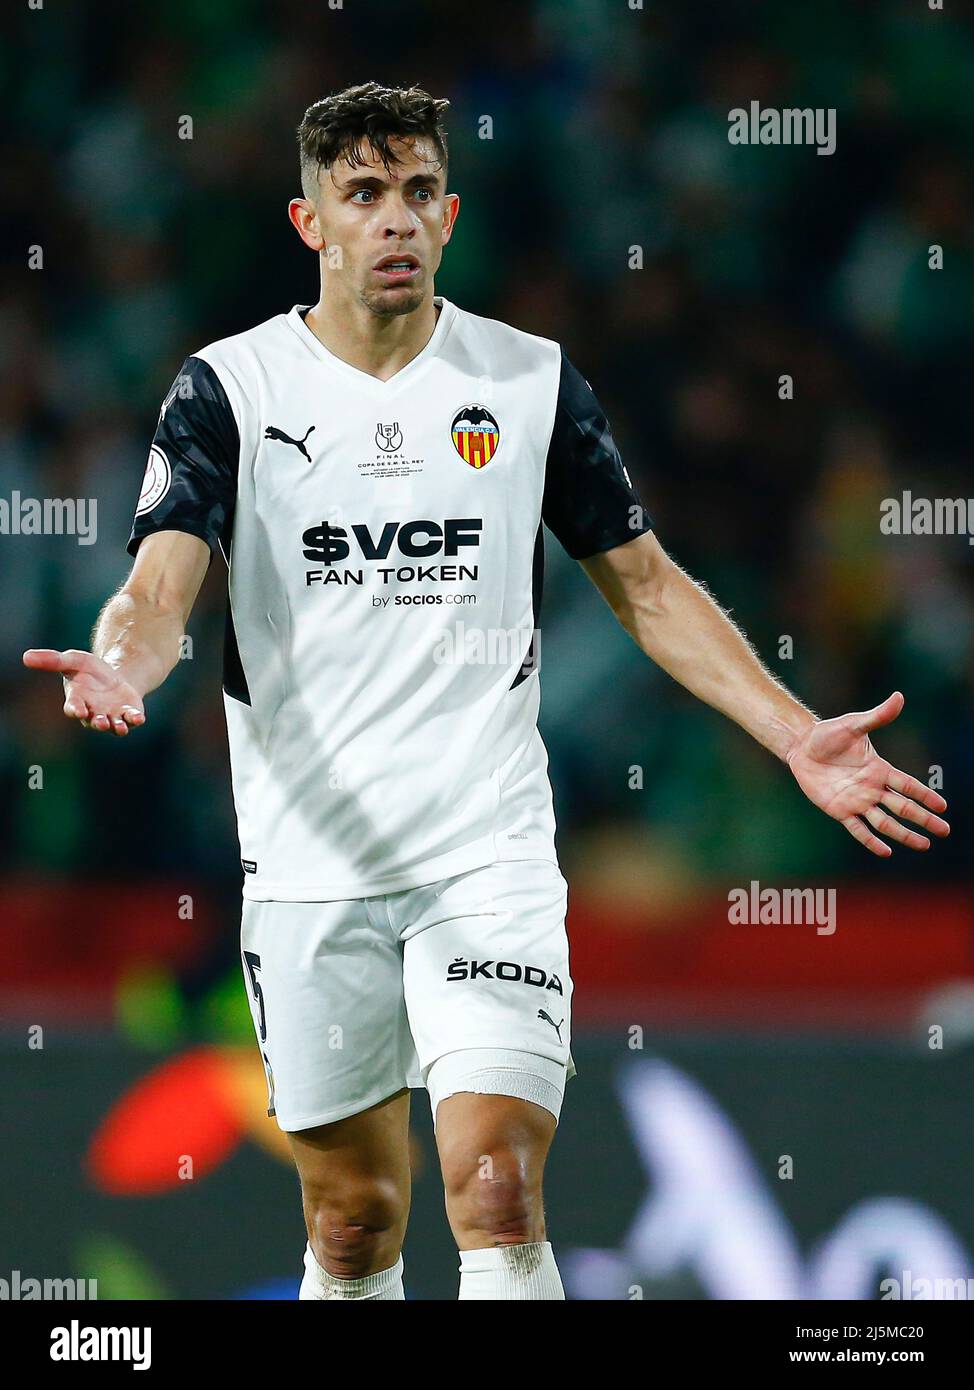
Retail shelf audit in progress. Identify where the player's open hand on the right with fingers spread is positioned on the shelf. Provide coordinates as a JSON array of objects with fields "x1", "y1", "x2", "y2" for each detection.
[{"x1": 788, "y1": 691, "x2": 950, "y2": 858}]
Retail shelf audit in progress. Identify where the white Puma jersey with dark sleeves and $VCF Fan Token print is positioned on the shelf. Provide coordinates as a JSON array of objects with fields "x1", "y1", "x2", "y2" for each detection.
[{"x1": 129, "y1": 296, "x2": 650, "y2": 902}]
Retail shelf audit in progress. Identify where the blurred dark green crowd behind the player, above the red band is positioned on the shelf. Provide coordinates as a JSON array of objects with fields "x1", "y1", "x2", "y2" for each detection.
[{"x1": 0, "y1": 0, "x2": 974, "y2": 911}]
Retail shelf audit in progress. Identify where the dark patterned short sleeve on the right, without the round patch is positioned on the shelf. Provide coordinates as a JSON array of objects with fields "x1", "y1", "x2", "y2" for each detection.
[{"x1": 542, "y1": 350, "x2": 653, "y2": 560}]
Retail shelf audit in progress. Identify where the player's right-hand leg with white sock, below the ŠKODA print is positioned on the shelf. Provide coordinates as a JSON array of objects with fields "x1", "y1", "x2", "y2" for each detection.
[{"x1": 436, "y1": 1091, "x2": 564, "y2": 1300}]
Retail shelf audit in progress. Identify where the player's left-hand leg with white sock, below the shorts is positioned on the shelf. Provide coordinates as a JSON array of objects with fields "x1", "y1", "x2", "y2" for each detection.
[{"x1": 288, "y1": 1091, "x2": 410, "y2": 1298}]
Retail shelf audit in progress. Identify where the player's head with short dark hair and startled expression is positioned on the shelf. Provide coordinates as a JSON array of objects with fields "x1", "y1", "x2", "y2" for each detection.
[{"x1": 289, "y1": 82, "x2": 460, "y2": 317}]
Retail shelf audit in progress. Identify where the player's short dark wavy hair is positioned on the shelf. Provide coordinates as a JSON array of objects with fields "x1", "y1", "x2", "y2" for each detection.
[{"x1": 297, "y1": 82, "x2": 450, "y2": 193}]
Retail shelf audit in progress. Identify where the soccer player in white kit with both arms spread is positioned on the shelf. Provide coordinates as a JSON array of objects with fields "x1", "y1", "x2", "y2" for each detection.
[{"x1": 24, "y1": 82, "x2": 948, "y2": 1300}]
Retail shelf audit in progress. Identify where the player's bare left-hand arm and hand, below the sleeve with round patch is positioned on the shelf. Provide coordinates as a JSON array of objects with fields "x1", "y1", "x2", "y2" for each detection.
[{"x1": 24, "y1": 531, "x2": 210, "y2": 735}]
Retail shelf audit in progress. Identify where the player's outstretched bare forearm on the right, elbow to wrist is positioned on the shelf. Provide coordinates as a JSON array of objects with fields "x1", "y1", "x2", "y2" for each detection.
[{"x1": 613, "y1": 564, "x2": 816, "y2": 759}]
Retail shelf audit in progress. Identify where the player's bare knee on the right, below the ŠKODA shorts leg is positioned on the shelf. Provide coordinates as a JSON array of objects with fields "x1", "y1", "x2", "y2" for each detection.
[{"x1": 443, "y1": 1150, "x2": 543, "y2": 1245}]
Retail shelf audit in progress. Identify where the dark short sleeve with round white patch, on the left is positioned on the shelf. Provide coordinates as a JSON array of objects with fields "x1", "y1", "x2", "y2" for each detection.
[{"x1": 128, "y1": 357, "x2": 240, "y2": 555}]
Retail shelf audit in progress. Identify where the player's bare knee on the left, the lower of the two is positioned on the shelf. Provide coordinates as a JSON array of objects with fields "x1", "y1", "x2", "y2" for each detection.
[{"x1": 304, "y1": 1180, "x2": 406, "y2": 1279}]
